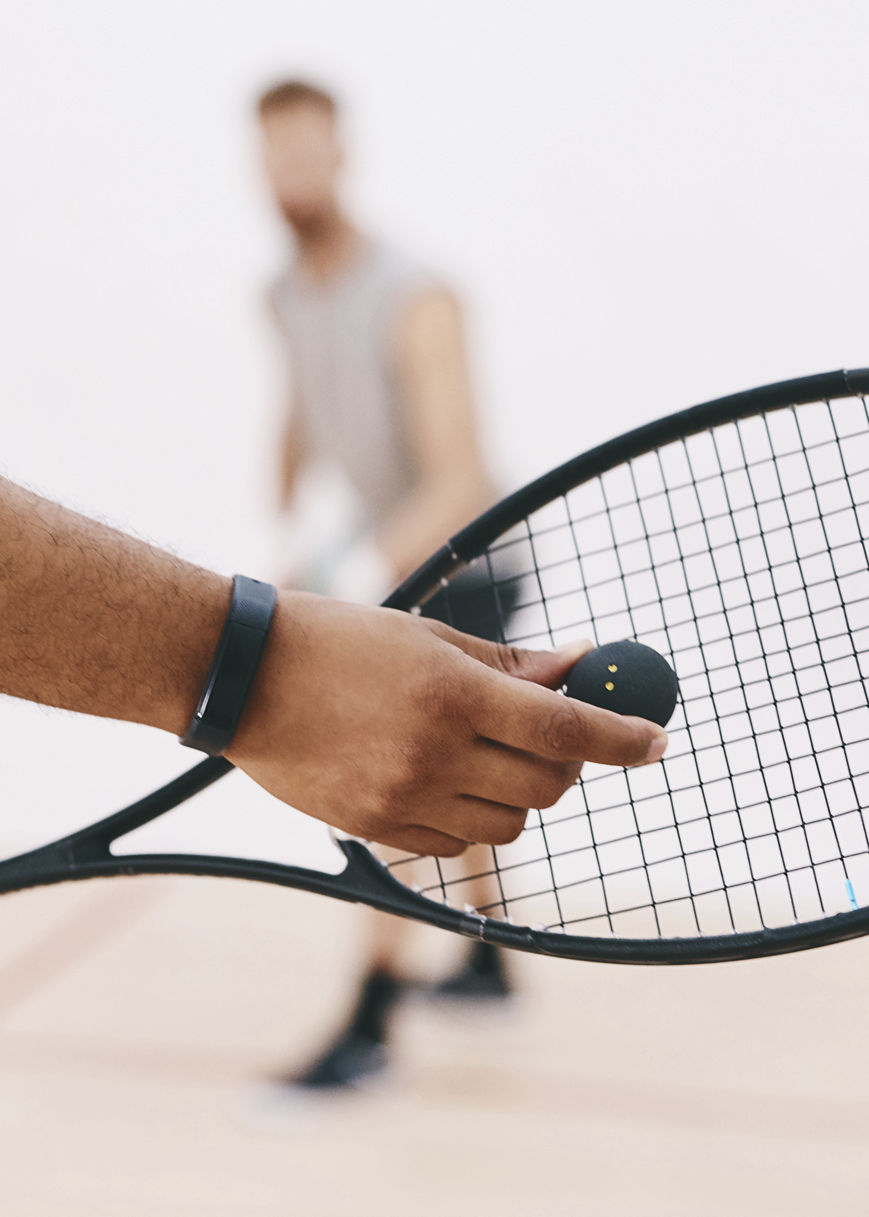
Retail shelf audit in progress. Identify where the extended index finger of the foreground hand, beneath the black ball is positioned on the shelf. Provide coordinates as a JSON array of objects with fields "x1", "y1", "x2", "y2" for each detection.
[{"x1": 471, "y1": 668, "x2": 667, "y2": 767}]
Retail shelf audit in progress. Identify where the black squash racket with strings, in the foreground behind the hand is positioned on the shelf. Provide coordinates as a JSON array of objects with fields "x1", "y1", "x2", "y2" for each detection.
[{"x1": 0, "y1": 369, "x2": 869, "y2": 963}]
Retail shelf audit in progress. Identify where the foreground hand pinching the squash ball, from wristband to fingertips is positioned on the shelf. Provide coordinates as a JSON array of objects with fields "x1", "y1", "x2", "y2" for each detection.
[{"x1": 226, "y1": 591, "x2": 667, "y2": 857}]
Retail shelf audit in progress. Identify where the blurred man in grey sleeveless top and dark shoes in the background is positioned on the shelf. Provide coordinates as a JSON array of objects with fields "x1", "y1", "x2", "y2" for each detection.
[{"x1": 259, "y1": 80, "x2": 509, "y2": 1090}]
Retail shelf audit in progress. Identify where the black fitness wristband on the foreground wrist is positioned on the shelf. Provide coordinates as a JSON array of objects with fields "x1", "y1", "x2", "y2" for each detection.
[{"x1": 181, "y1": 574, "x2": 277, "y2": 757}]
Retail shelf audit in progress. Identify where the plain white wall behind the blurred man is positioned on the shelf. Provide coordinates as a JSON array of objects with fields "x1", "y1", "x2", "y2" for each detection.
[{"x1": 0, "y1": 0, "x2": 869, "y2": 849}]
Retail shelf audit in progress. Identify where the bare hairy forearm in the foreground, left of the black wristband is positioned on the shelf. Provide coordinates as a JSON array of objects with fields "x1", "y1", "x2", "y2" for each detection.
[{"x1": 0, "y1": 479, "x2": 230, "y2": 735}]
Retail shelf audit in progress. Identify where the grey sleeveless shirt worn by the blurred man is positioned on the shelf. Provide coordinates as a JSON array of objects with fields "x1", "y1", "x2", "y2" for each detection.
[{"x1": 273, "y1": 239, "x2": 435, "y2": 528}]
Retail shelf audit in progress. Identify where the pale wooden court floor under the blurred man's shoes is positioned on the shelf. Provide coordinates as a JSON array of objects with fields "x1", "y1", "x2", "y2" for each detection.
[{"x1": 0, "y1": 879, "x2": 869, "y2": 1217}]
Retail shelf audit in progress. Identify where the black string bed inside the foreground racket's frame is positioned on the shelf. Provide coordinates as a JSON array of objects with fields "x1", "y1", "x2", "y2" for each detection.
[{"x1": 379, "y1": 397, "x2": 869, "y2": 937}]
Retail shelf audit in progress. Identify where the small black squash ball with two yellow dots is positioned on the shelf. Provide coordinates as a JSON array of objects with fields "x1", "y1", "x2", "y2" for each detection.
[{"x1": 567, "y1": 640, "x2": 679, "y2": 727}]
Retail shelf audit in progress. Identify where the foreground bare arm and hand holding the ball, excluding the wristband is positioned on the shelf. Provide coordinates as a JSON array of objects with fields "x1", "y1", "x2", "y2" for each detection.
[{"x1": 0, "y1": 469, "x2": 666, "y2": 854}]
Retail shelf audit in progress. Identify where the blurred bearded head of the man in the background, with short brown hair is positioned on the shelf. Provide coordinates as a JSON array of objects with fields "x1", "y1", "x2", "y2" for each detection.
[{"x1": 258, "y1": 80, "x2": 343, "y2": 236}]
